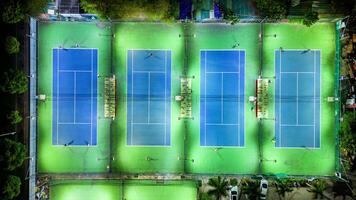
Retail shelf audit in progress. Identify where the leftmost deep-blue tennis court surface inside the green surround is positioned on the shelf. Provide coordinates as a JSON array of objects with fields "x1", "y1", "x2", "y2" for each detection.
[{"x1": 52, "y1": 49, "x2": 98, "y2": 146}]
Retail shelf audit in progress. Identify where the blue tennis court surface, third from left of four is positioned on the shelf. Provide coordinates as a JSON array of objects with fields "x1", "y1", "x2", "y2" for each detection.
[{"x1": 200, "y1": 50, "x2": 245, "y2": 146}]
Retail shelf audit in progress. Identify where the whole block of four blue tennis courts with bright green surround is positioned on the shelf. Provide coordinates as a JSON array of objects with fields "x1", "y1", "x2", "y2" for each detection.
[{"x1": 36, "y1": 22, "x2": 337, "y2": 176}]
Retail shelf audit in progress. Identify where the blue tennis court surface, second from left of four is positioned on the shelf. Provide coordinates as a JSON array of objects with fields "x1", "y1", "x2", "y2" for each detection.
[{"x1": 127, "y1": 50, "x2": 171, "y2": 146}]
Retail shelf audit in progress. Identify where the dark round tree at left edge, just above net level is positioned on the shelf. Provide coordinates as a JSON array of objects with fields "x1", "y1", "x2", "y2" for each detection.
[{"x1": 0, "y1": 69, "x2": 28, "y2": 94}]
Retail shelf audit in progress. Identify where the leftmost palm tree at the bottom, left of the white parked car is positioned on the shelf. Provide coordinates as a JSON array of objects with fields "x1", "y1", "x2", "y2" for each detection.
[{"x1": 208, "y1": 176, "x2": 229, "y2": 200}]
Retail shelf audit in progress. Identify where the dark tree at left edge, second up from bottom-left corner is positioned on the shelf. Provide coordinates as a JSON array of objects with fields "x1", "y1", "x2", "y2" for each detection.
[{"x1": 0, "y1": 138, "x2": 27, "y2": 171}]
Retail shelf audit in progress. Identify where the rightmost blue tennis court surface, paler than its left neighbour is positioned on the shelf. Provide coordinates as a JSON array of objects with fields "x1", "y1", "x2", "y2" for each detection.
[{"x1": 275, "y1": 50, "x2": 320, "y2": 148}]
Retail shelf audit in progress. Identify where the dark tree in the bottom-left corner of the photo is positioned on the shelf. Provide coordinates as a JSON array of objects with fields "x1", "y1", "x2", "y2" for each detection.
[{"x1": 0, "y1": 175, "x2": 21, "y2": 200}]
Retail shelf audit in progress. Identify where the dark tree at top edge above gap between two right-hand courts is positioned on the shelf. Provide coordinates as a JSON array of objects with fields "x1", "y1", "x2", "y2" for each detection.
[{"x1": 255, "y1": 0, "x2": 288, "y2": 19}]
